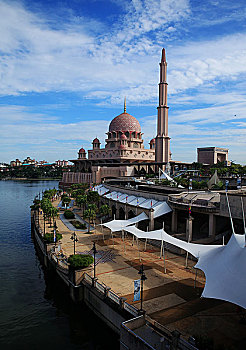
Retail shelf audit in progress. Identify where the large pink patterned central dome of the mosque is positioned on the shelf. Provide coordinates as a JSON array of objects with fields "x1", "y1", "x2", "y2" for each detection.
[{"x1": 109, "y1": 112, "x2": 141, "y2": 132}]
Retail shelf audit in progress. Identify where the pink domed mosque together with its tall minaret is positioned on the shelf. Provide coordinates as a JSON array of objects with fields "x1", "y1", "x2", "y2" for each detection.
[{"x1": 62, "y1": 49, "x2": 184, "y2": 184}]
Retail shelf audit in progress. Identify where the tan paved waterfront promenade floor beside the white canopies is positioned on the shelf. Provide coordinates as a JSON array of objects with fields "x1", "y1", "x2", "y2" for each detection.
[{"x1": 40, "y1": 202, "x2": 246, "y2": 349}]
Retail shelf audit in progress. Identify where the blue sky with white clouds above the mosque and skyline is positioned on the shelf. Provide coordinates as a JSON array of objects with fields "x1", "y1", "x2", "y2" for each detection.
[{"x1": 0, "y1": 0, "x2": 246, "y2": 164}]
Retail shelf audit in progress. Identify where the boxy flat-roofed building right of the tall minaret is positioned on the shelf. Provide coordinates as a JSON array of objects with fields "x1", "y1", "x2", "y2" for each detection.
[{"x1": 197, "y1": 147, "x2": 228, "y2": 165}]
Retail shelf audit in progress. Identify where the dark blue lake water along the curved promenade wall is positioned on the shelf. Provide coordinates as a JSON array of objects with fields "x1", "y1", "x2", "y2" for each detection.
[{"x1": 0, "y1": 181, "x2": 119, "y2": 350}]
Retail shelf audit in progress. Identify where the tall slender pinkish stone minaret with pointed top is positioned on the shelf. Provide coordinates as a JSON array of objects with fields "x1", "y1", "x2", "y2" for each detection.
[{"x1": 155, "y1": 49, "x2": 170, "y2": 167}]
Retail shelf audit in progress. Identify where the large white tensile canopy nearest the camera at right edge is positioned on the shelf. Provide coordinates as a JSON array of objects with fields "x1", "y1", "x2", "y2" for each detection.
[{"x1": 124, "y1": 226, "x2": 246, "y2": 309}]
